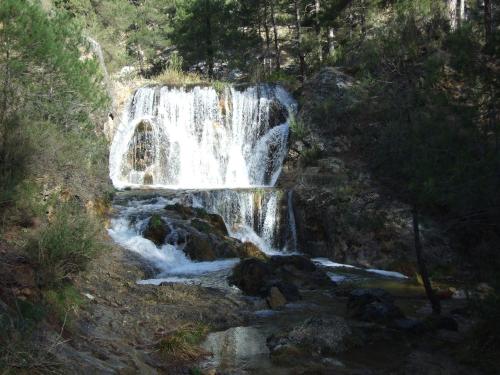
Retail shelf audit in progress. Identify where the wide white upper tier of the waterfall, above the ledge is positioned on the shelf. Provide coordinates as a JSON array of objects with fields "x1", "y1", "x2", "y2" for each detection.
[{"x1": 110, "y1": 85, "x2": 296, "y2": 189}]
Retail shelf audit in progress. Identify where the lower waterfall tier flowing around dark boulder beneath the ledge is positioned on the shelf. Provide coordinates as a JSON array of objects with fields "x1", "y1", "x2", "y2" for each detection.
[{"x1": 109, "y1": 189, "x2": 296, "y2": 275}]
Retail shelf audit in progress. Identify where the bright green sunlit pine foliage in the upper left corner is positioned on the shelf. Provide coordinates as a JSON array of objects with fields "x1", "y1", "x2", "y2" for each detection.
[{"x1": 0, "y1": 0, "x2": 106, "y2": 126}]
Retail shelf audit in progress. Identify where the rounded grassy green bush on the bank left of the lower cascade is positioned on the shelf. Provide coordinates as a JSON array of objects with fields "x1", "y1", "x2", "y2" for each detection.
[{"x1": 26, "y1": 203, "x2": 104, "y2": 288}]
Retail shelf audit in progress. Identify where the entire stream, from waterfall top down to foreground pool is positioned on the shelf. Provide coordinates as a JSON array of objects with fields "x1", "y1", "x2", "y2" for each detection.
[{"x1": 109, "y1": 85, "x2": 414, "y2": 374}]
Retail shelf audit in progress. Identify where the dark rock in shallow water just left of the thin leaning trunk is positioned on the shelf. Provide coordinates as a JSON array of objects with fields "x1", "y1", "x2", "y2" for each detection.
[{"x1": 347, "y1": 288, "x2": 404, "y2": 323}]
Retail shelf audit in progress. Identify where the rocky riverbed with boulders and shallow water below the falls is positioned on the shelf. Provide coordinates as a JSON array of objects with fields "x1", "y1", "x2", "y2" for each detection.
[{"x1": 39, "y1": 197, "x2": 475, "y2": 374}]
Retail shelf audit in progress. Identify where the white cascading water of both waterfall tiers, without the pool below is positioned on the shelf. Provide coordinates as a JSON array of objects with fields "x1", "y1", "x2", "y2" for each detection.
[{"x1": 110, "y1": 85, "x2": 296, "y2": 275}]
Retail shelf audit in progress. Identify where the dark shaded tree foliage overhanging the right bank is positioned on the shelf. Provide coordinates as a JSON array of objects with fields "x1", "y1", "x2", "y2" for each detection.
[{"x1": 334, "y1": 0, "x2": 500, "y2": 264}]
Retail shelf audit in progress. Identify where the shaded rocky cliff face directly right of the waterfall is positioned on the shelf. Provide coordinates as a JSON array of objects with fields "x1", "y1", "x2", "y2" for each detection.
[{"x1": 278, "y1": 68, "x2": 447, "y2": 273}]
